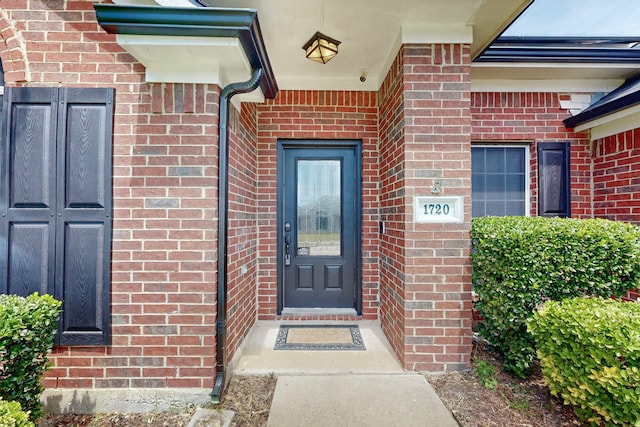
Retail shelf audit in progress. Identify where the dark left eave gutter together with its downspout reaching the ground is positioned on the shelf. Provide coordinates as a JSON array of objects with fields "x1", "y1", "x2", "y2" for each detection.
[{"x1": 94, "y1": 4, "x2": 278, "y2": 403}]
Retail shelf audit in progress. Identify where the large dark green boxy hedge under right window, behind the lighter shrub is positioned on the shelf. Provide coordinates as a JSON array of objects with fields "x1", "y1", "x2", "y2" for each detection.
[{"x1": 471, "y1": 217, "x2": 640, "y2": 377}]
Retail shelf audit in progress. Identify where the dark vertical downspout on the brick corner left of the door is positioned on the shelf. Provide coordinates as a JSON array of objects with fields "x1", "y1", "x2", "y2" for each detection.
[{"x1": 211, "y1": 68, "x2": 263, "y2": 403}]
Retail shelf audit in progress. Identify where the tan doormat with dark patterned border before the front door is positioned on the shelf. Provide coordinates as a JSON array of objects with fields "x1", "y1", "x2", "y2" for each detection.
[{"x1": 273, "y1": 325, "x2": 366, "y2": 350}]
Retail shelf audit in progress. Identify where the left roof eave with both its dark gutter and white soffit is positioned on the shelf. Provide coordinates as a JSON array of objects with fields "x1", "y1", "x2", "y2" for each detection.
[{"x1": 94, "y1": 4, "x2": 278, "y2": 102}]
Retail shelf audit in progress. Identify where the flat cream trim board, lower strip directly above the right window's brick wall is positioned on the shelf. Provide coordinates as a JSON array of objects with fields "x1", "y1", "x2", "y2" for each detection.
[{"x1": 471, "y1": 79, "x2": 624, "y2": 93}]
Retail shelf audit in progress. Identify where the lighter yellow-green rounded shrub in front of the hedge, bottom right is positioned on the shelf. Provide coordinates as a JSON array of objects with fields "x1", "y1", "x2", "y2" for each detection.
[{"x1": 529, "y1": 298, "x2": 640, "y2": 426}]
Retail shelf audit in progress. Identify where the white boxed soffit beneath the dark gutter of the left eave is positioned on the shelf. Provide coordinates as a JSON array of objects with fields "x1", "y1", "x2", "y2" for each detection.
[{"x1": 117, "y1": 34, "x2": 264, "y2": 102}]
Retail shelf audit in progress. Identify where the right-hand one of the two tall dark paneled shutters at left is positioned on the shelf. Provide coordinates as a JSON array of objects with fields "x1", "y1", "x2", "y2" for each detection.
[{"x1": 54, "y1": 88, "x2": 114, "y2": 345}]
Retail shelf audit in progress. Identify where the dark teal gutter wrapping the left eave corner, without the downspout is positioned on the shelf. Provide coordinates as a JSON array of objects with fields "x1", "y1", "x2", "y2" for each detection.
[{"x1": 93, "y1": 4, "x2": 278, "y2": 99}]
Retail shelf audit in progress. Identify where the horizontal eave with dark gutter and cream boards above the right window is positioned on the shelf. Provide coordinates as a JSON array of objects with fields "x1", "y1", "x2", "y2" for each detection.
[{"x1": 471, "y1": 37, "x2": 640, "y2": 92}]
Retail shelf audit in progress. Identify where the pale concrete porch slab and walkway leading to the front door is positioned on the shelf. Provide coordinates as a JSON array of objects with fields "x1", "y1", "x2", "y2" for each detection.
[{"x1": 234, "y1": 321, "x2": 458, "y2": 427}]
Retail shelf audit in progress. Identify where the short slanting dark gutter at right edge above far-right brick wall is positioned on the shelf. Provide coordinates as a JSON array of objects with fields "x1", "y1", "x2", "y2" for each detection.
[{"x1": 562, "y1": 76, "x2": 640, "y2": 128}]
